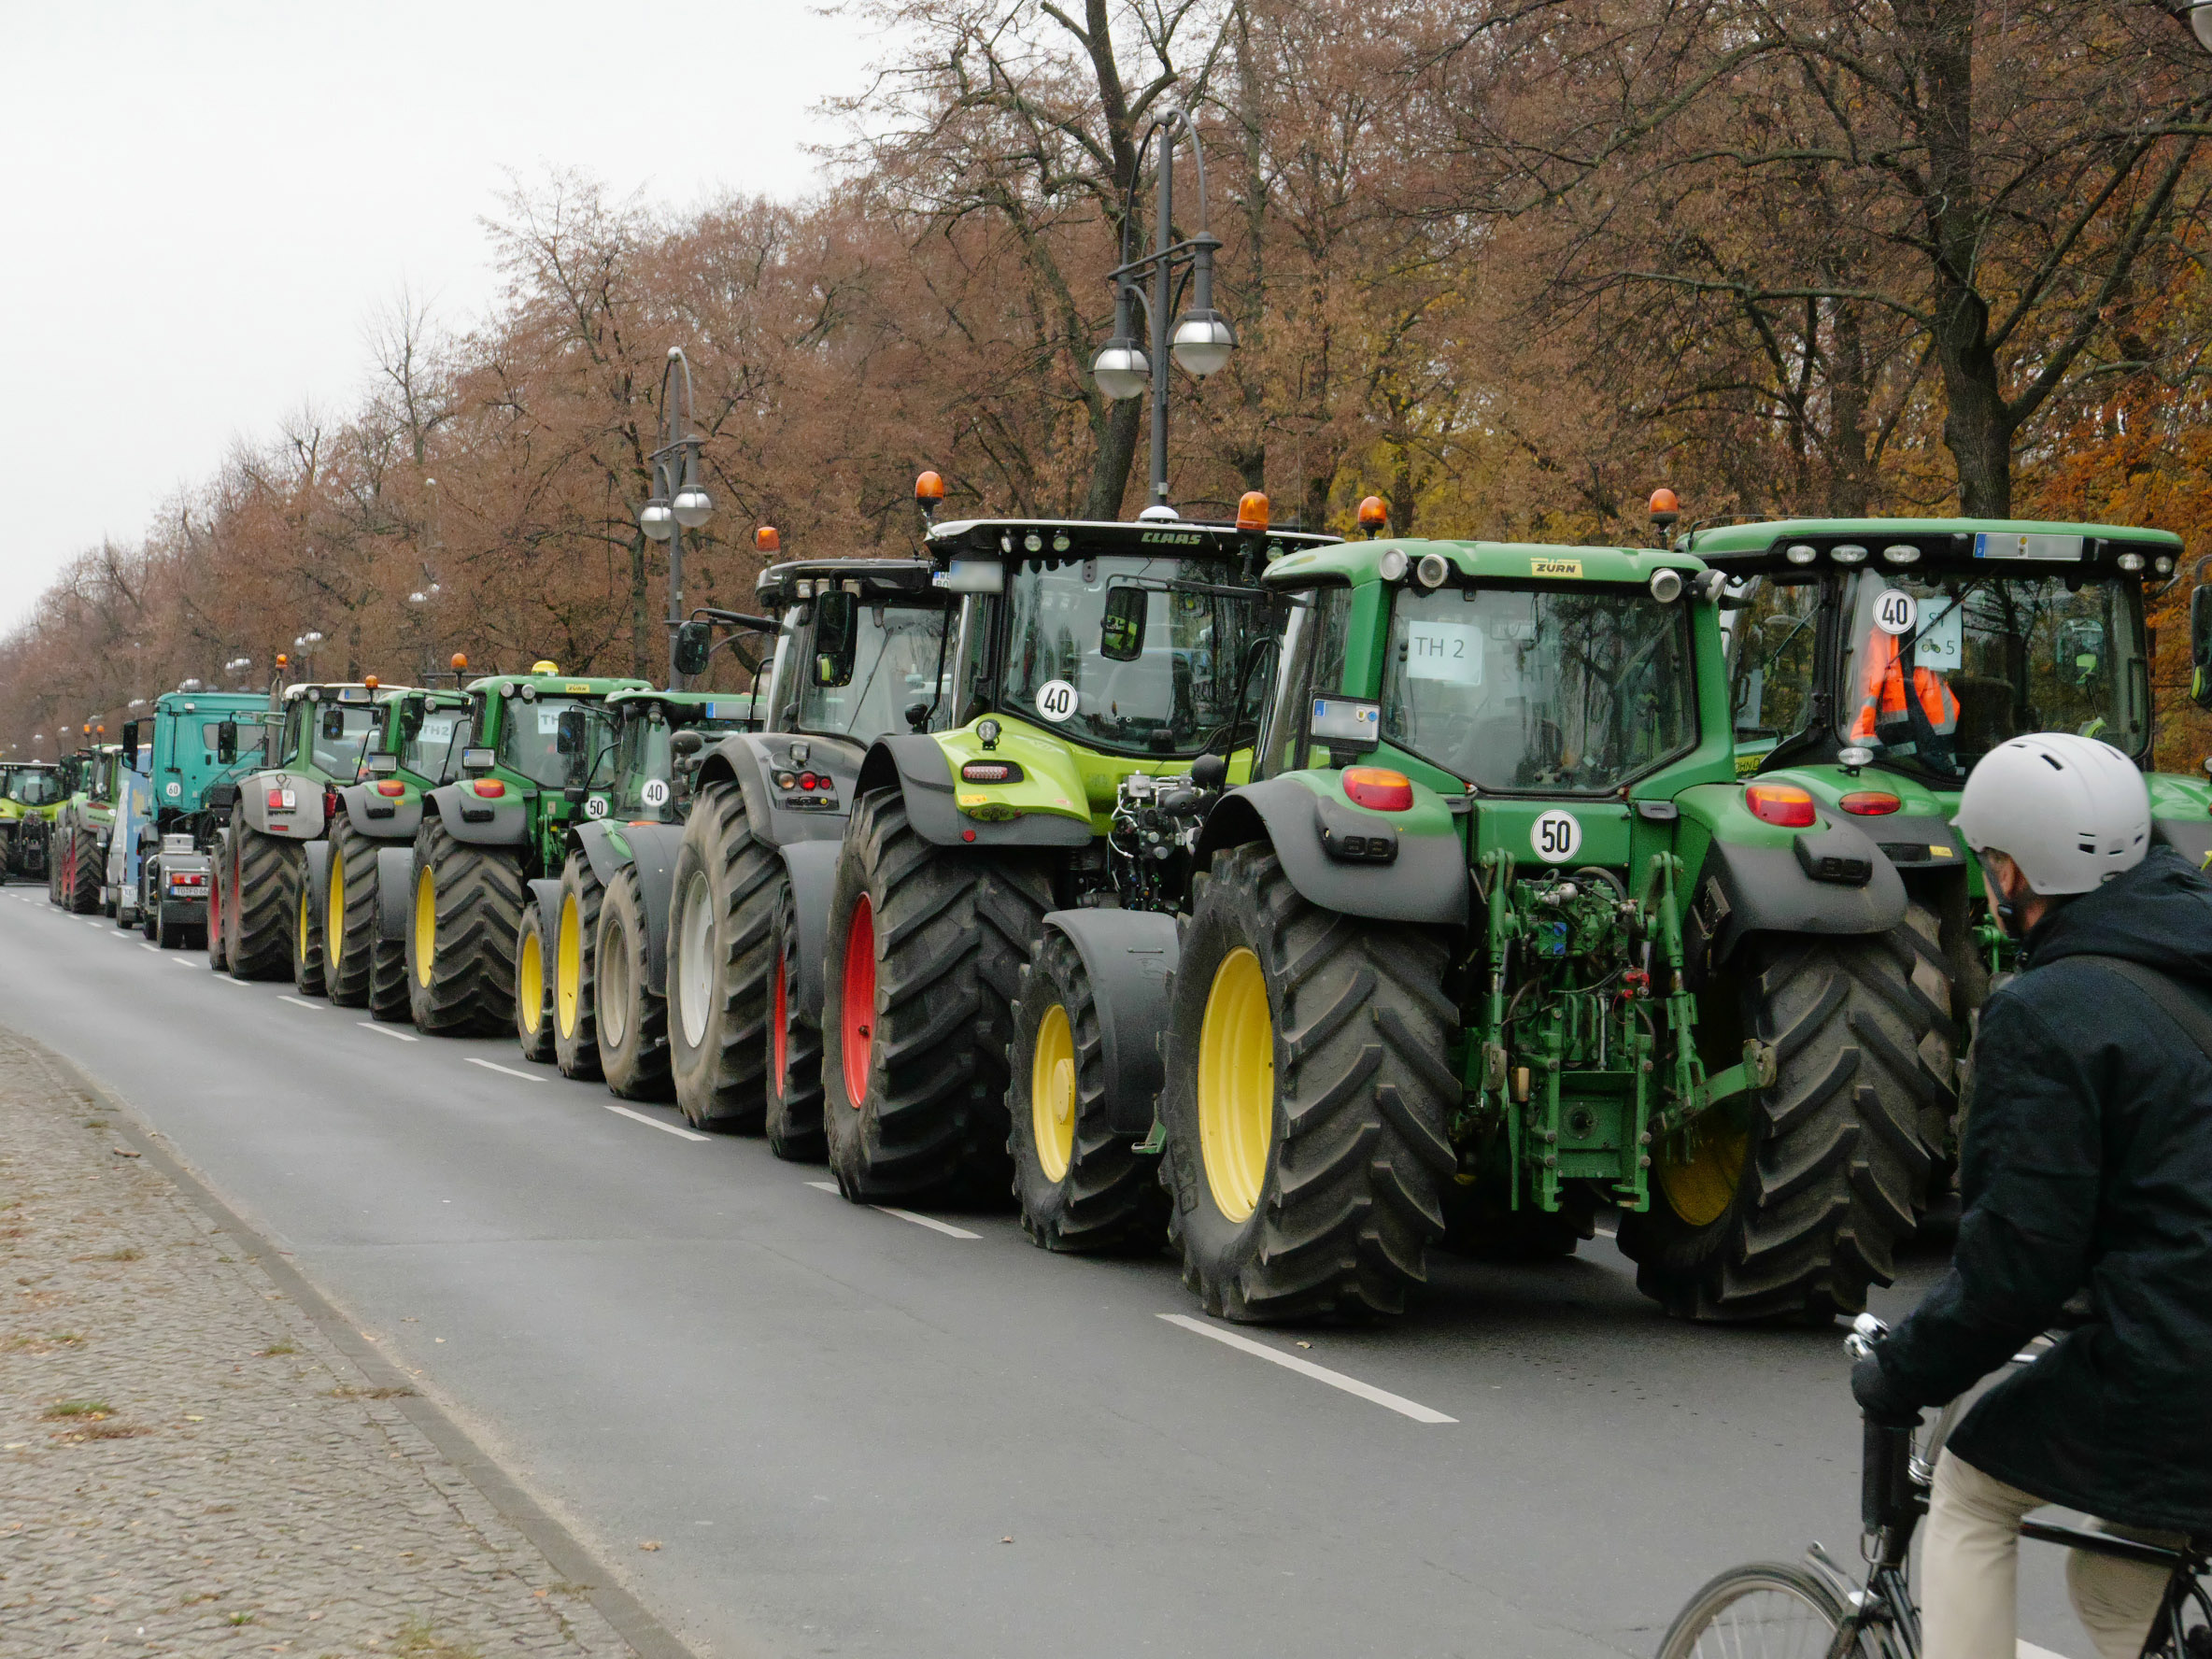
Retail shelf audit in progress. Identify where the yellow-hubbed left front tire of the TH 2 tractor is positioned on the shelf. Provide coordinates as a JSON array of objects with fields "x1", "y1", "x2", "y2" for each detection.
[{"x1": 1006, "y1": 933, "x2": 1168, "y2": 1255}]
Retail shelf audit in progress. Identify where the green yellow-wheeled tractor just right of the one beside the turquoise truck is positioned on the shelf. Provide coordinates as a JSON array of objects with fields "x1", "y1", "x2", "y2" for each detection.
[{"x1": 292, "y1": 686, "x2": 469, "y2": 1022}]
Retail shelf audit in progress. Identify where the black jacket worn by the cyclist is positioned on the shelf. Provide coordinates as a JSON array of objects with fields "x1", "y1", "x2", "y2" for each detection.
[{"x1": 1876, "y1": 847, "x2": 2212, "y2": 1535}]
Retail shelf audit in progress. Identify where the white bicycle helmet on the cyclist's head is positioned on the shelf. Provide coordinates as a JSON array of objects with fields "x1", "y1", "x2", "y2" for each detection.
[{"x1": 1953, "y1": 732, "x2": 2150, "y2": 894}]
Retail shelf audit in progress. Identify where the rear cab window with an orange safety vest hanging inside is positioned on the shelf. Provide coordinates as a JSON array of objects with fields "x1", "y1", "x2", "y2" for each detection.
[{"x1": 1836, "y1": 569, "x2": 2150, "y2": 787}]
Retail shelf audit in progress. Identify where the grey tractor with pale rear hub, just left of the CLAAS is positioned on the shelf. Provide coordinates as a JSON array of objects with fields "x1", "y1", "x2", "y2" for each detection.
[{"x1": 666, "y1": 560, "x2": 956, "y2": 1161}]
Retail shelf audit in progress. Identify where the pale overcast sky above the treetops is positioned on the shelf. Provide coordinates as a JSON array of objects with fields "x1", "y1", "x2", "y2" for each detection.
[{"x1": 0, "y1": 0, "x2": 878, "y2": 631}]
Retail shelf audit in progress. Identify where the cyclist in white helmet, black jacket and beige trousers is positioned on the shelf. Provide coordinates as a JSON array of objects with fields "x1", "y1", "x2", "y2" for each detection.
[{"x1": 1851, "y1": 732, "x2": 2212, "y2": 1659}]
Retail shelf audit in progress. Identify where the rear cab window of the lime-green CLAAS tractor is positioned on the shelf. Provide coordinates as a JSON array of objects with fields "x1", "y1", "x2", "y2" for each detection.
[{"x1": 1004, "y1": 555, "x2": 1261, "y2": 754}]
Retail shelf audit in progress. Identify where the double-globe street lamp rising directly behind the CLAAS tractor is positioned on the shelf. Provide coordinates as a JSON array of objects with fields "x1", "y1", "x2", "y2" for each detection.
[{"x1": 1090, "y1": 108, "x2": 1237, "y2": 518}]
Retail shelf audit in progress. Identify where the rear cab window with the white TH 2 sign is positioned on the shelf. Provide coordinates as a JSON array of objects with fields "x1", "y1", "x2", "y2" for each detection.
[{"x1": 1382, "y1": 588, "x2": 1696, "y2": 794}]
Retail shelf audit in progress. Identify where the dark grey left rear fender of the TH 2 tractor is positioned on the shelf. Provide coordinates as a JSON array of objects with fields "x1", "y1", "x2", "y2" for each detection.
[{"x1": 1197, "y1": 779, "x2": 1468, "y2": 927}]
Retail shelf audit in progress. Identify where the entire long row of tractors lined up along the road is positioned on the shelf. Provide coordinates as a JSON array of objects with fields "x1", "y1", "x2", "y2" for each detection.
[{"x1": 49, "y1": 475, "x2": 2212, "y2": 1321}]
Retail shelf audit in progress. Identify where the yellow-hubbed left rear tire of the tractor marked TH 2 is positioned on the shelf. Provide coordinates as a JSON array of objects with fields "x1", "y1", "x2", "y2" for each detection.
[{"x1": 1159, "y1": 843, "x2": 1460, "y2": 1323}]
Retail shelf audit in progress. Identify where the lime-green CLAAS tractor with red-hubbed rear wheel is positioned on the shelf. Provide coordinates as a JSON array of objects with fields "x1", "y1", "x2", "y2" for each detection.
[{"x1": 799, "y1": 495, "x2": 1332, "y2": 1221}]
